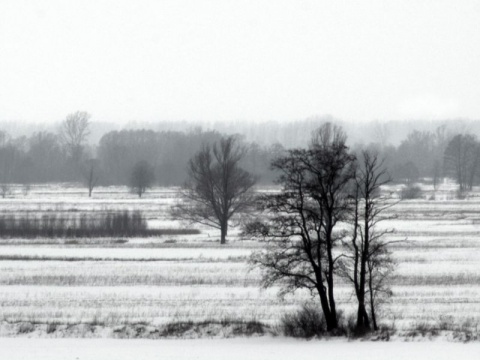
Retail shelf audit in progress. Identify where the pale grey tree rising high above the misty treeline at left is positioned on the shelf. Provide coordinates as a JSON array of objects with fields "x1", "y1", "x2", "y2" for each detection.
[{"x1": 59, "y1": 111, "x2": 91, "y2": 165}]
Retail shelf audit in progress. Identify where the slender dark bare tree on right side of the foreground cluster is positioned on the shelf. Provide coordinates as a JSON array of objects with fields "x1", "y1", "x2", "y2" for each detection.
[{"x1": 341, "y1": 151, "x2": 395, "y2": 333}]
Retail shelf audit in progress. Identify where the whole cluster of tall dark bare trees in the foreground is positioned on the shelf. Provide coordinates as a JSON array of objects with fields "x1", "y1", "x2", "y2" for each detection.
[{"x1": 218, "y1": 123, "x2": 392, "y2": 331}]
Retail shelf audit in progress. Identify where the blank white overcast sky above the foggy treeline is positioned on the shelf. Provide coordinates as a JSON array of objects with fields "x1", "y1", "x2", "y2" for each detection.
[{"x1": 0, "y1": 0, "x2": 480, "y2": 122}]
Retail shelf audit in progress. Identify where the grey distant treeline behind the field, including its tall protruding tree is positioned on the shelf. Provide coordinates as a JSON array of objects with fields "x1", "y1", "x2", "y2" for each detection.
[{"x1": 0, "y1": 112, "x2": 480, "y2": 195}]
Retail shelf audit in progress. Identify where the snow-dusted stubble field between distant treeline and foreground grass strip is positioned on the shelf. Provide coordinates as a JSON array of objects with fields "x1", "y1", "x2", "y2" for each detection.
[{"x1": 0, "y1": 185, "x2": 480, "y2": 338}]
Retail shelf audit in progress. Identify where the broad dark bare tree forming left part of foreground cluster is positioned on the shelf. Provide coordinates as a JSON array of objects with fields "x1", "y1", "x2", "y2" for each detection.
[{"x1": 251, "y1": 123, "x2": 355, "y2": 331}]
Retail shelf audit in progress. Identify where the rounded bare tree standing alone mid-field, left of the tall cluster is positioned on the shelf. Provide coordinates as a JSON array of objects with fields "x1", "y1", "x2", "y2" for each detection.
[{"x1": 172, "y1": 136, "x2": 256, "y2": 244}]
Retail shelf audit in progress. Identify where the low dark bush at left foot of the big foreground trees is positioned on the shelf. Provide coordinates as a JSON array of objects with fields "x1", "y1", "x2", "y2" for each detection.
[{"x1": 280, "y1": 304, "x2": 327, "y2": 339}]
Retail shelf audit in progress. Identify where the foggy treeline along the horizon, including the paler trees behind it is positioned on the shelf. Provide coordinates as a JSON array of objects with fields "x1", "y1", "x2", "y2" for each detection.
[{"x1": 0, "y1": 118, "x2": 480, "y2": 188}]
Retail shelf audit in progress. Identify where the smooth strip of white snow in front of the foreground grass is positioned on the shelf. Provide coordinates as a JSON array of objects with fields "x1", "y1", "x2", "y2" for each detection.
[{"x1": 0, "y1": 338, "x2": 480, "y2": 360}]
